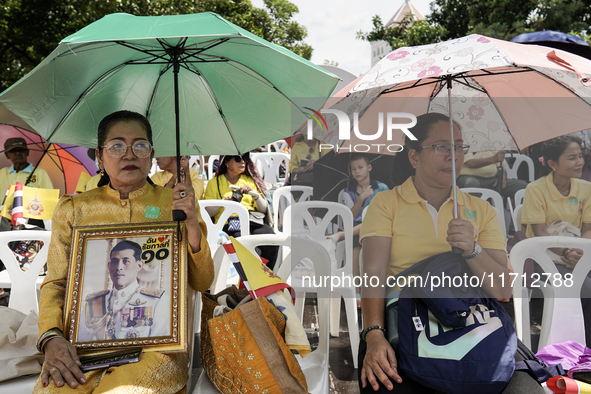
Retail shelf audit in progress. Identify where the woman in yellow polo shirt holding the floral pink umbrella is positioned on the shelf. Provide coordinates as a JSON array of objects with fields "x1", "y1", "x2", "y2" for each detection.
[{"x1": 359, "y1": 113, "x2": 543, "y2": 394}]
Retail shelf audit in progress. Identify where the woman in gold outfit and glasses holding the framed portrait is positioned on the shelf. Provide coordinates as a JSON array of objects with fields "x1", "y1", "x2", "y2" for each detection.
[{"x1": 35, "y1": 111, "x2": 214, "y2": 394}]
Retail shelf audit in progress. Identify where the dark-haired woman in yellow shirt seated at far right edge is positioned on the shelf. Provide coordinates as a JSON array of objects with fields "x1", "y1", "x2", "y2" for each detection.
[{"x1": 521, "y1": 135, "x2": 591, "y2": 346}]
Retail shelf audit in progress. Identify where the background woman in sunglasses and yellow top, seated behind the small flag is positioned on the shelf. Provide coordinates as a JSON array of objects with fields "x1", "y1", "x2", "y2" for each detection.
[{"x1": 205, "y1": 153, "x2": 279, "y2": 269}]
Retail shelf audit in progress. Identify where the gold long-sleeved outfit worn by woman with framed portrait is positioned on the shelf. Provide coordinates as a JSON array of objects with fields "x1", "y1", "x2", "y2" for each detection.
[{"x1": 34, "y1": 183, "x2": 214, "y2": 394}]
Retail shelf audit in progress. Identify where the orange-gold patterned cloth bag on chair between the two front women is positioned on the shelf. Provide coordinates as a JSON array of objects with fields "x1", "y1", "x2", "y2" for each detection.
[{"x1": 200, "y1": 286, "x2": 308, "y2": 394}]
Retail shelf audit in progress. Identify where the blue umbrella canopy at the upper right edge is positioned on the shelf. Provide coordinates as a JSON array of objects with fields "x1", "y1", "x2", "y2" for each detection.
[{"x1": 511, "y1": 30, "x2": 591, "y2": 59}]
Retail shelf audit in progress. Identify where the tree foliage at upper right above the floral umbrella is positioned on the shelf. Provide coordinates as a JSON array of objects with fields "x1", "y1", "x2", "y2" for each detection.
[{"x1": 357, "y1": 0, "x2": 591, "y2": 49}]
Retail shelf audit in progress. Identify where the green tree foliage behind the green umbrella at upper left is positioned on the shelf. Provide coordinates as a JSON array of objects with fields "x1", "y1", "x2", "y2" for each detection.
[{"x1": 0, "y1": 0, "x2": 312, "y2": 91}]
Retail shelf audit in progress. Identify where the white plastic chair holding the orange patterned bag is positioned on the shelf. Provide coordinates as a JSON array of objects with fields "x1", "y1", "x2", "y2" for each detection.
[{"x1": 193, "y1": 234, "x2": 330, "y2": 394}]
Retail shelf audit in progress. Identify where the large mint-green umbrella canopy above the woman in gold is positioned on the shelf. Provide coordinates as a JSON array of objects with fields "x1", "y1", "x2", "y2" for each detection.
[{"x1": 0, "y1": 13, "x2": 338, "y2": 156}]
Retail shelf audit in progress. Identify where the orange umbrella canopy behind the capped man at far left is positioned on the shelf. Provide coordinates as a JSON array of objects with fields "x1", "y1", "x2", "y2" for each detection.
[{"x1": 0, "y1": 125, "x2": 96, "y2": 194}]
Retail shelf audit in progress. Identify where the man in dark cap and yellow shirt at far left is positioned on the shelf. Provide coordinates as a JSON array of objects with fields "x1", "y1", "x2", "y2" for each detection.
[{"x1": 0, "y1": 138, "x2": 53, "y2": 198}]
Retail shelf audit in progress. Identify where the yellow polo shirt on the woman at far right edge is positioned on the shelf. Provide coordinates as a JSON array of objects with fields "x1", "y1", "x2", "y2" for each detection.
[{"x1": 521, "y1": 172, "x2": 591, "y2": 237}]
